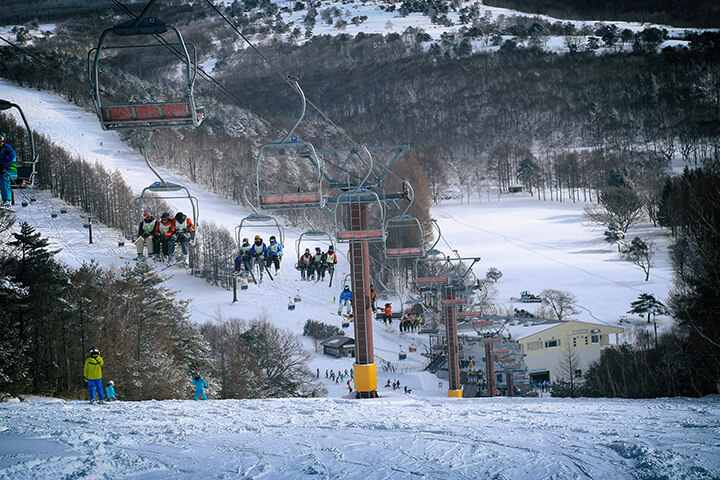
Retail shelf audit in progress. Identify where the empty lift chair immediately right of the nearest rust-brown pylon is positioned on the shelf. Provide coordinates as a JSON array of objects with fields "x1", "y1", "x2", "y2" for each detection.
[{"x1": 385, "y1": 180, "x2": 425, "y2": 258}]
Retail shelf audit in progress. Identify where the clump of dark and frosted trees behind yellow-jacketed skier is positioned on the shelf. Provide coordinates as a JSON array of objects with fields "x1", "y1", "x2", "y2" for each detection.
[{"x1": 0, "y1": 220, "x2": 325, "y2": 400}]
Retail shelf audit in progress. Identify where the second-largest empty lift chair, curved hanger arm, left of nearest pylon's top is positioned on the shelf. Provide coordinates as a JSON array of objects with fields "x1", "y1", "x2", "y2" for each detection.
[{"x1": 255, "y1": 77, "x2": 325, "y2": 209}]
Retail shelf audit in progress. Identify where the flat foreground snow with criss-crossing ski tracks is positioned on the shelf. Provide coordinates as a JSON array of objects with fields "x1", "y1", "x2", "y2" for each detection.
[{"x1": 0, "y1": 395, "x2": 720, "y2": 479}]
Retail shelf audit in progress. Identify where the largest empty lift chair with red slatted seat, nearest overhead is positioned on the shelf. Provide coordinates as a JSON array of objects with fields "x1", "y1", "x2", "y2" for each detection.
[{"x1": 88, "y1": 0, "x2": 205, "y2": 130}]
